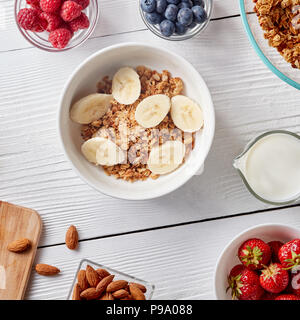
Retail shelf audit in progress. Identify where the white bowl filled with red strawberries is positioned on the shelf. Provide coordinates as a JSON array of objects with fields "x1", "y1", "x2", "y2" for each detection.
[{"x1": 214, "y1": 224, "x2": 300, "y2": 300}]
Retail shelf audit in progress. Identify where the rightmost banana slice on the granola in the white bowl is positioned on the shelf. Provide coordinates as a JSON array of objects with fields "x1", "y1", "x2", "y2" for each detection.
[{"x1": 171, "y1": 95, "x2": 203, "y2": 132}]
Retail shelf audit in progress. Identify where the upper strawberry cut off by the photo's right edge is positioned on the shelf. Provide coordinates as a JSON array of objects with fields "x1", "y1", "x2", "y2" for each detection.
[{"x1": 278, "y1": 239, "x2": 300, "y2": 269}]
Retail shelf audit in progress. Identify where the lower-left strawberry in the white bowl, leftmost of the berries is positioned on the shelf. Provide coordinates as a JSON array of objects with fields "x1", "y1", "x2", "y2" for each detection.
[{"x1": 227, "y1": 264, "x2": 264, "y2": 300}]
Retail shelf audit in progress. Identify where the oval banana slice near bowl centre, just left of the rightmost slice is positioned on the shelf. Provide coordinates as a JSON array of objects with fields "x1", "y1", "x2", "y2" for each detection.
[{"x1": 135, "y1": 94, "x2": 171, "y2": 128}]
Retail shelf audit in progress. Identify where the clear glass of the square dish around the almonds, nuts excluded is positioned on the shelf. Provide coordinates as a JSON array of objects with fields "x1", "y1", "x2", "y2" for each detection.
[{"x1": 67, "y1": 259, "x2": 155, "y2": 300}]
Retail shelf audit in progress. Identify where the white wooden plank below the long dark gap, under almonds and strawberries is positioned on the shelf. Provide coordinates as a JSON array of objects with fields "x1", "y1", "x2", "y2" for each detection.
[{"x1": 25, "y1": 208, "x2": 300, "y2": 300}]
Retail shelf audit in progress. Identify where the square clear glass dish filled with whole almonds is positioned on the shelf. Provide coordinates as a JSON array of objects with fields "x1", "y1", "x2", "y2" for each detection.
[{"x1": 68, "y1": 259, "x2": 154, "y2": 300}]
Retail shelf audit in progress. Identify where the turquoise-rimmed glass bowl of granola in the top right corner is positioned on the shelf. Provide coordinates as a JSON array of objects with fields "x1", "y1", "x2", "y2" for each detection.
[{"x1": 240, "y1": 0, "x2": 300, "y2": 89}]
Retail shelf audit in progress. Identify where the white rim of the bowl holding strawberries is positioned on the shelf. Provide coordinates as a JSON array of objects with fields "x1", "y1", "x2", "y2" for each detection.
[{"x1": 213, "y1": 223, "x2": 300, "y2": 300}]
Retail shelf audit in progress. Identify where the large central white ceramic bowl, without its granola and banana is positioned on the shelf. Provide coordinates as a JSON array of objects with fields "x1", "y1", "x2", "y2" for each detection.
[{"x1": 59, "y1": 43, "x2": 215, "y2": 200}]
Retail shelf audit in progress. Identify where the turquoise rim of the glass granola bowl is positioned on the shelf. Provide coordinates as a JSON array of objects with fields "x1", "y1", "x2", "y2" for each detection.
[{"x1": 240, "y1": 0, "x2": 300, "y2": 90}]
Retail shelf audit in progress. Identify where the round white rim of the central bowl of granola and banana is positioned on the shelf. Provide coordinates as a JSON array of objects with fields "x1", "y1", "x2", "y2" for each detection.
[{"x1": 57, "y1": 42, "x2": 215, "y2": 201}]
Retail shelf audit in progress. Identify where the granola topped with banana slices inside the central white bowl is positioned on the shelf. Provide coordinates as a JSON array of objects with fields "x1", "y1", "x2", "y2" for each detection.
[{"x1": 71, "y1": 66, "x2": 203, "y2": 182}]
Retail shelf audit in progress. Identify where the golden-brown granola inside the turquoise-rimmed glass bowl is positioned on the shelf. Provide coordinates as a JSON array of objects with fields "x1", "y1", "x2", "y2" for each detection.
[{"x1": 254, "y1": 0, "x2": 300, "y2": 69}]
